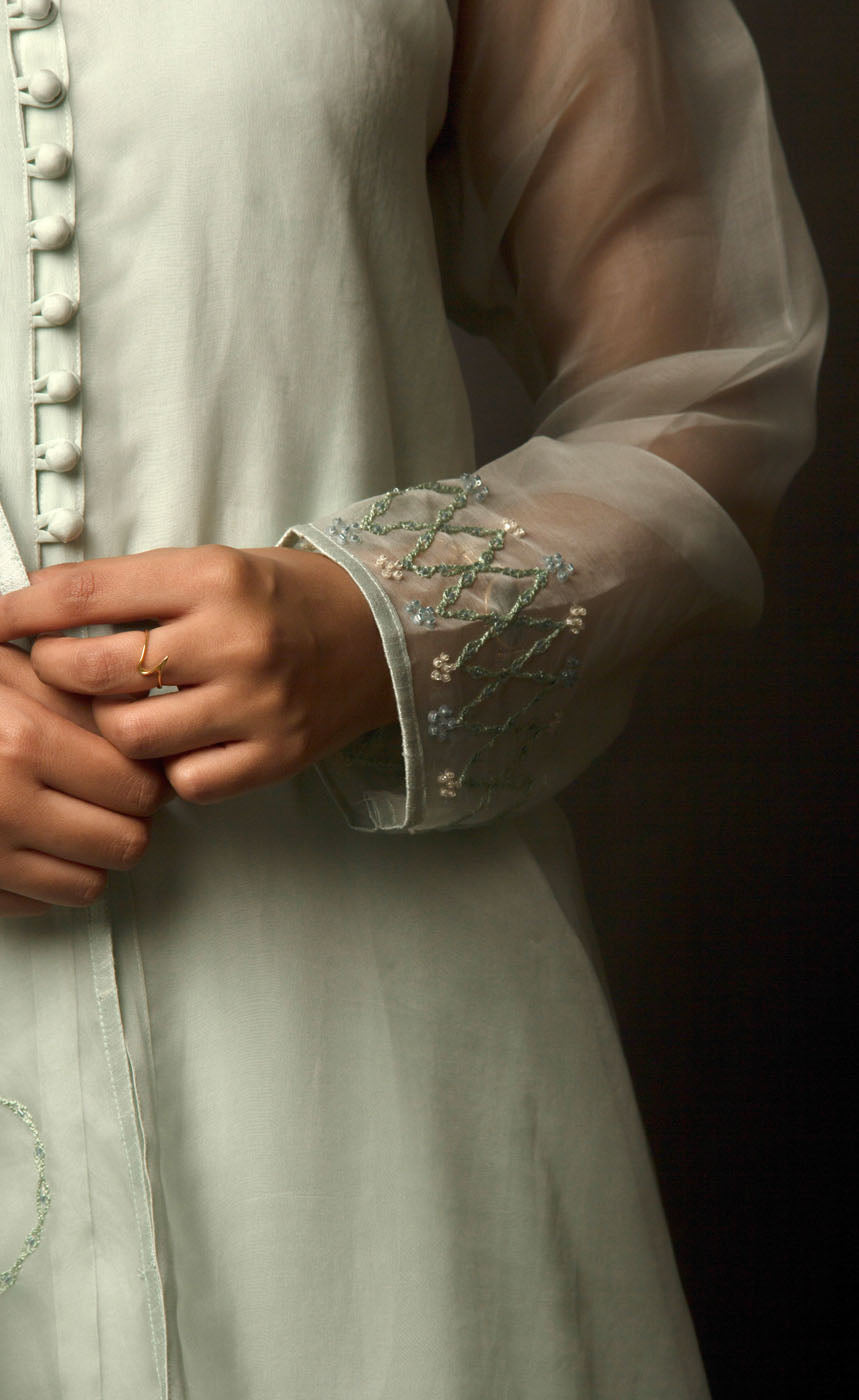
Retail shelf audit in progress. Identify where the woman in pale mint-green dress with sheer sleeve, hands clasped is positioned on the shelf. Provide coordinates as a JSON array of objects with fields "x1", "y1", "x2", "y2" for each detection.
[{"x1": 0, "y1": 0, "x2": 825, "y2": 1400}]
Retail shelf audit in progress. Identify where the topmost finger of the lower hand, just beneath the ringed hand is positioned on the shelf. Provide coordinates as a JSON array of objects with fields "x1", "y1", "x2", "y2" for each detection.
[{"x1": 32, "y1": 711, "x2": 168, "y2": 816}]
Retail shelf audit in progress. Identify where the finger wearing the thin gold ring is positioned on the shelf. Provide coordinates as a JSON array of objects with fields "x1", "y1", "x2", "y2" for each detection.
[{"x1": 31, "y1": 622, "x2": 205, "y2": 696}]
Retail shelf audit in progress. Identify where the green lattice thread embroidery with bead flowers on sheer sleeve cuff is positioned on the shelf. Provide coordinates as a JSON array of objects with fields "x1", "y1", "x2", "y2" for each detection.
[{"x1": 329, "y1": 473, "x2": 586, "y2": 825}]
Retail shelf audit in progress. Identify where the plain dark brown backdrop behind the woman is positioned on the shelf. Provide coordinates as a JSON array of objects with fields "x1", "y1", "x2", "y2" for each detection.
[{"x1": 460, "y1": 0, "x2": 859, "y2": 1400}]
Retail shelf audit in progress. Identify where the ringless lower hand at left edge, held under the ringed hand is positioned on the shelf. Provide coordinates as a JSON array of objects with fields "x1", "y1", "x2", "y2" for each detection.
[{"x1": 0, "y1": 645, "x2": 171, "y2": 917}]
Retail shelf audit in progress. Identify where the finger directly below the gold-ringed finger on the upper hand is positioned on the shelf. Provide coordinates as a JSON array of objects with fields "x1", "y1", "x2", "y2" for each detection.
[{"x1": 92, "y1": 685, "x2": 238, "y2": 759}]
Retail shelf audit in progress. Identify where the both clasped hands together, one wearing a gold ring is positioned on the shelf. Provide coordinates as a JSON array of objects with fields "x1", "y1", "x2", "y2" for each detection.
[{"x1": 0, "y1": 546, "x2": 396, "y2": 914}]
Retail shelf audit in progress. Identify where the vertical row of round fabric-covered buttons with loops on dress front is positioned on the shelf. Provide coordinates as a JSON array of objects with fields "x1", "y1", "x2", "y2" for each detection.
[{"x1": 6, "y1": 0, "x2": 84, "y2": 548}]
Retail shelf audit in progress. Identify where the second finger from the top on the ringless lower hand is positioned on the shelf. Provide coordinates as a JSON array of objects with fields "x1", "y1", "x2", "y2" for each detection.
[{"x1": 27, "y1": 788, "x2": 150, "y2": 871}]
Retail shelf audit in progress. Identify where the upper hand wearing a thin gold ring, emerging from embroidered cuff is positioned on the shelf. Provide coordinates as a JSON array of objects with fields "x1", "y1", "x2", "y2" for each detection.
[{"x1": 0, "y1": 545, "x2": 396, "y2": 802}]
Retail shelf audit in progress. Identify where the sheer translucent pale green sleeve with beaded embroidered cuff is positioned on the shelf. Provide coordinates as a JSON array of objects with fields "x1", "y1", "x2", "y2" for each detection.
[{"x1": 285, "y1": 0, "x2": 825, "y2": 832}]
